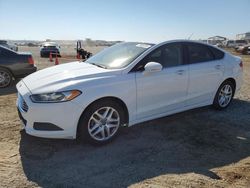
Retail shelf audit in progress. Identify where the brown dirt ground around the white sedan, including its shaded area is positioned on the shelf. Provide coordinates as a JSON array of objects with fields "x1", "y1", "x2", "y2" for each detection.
[{"x1": 0, "y1": 47, "x2": 250, "y2": 188}]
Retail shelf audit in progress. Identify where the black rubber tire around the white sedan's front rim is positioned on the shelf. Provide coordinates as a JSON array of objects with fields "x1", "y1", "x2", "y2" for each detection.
[{"x1": 77, "y1": 100, "x2": 125, "y2": 145}]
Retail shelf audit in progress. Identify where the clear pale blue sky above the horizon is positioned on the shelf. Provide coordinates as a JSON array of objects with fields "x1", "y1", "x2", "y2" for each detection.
[{"x1": 0, "y1": 0, "x2": 250, "y2": 42}]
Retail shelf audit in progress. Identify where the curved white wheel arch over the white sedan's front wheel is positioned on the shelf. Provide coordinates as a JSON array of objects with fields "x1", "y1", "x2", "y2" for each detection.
[{"x1": 76, "y1": 96, "x2": 129, "y2": 137}]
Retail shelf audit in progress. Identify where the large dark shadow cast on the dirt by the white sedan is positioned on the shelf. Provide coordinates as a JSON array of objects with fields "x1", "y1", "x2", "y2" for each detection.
[{"x1": 20, "y1": 99, "x2": 250, "y2": 188}]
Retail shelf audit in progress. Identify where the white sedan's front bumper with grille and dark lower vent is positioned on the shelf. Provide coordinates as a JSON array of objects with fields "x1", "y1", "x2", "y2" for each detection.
[{"x1": 17, "y1": 81, "x2": 82, "y2": 139}]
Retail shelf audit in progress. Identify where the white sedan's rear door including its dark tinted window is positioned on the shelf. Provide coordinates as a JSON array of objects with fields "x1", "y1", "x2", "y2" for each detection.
[{"x1": 185, "y1": 43, "x2": 224, "y2": 106}]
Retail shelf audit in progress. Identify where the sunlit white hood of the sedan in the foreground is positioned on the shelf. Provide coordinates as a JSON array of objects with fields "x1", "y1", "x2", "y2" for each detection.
[{"x1": 23, "y1": 61, "x2": 121, "y2": 94}]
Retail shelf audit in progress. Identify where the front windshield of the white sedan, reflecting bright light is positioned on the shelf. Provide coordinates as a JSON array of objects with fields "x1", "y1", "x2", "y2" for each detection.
[{"x1": 87, "y1": 42, "x2": 153, "y2": 69}]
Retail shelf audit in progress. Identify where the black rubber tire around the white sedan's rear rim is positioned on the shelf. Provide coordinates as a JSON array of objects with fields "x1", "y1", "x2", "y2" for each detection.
[{"x1": 213, "y1": 80, "x2": 235, "y2": 110}]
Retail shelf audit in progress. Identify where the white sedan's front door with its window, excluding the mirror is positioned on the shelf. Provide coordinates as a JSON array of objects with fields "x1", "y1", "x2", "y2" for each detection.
[{"x1": 136, "y1": 43, "x2": 188, "y2": 119}]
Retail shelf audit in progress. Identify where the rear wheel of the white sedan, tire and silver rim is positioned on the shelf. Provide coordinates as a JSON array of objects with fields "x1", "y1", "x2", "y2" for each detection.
[{"x1": 213, "y1": 81, "x2": 235, "y2": 110}]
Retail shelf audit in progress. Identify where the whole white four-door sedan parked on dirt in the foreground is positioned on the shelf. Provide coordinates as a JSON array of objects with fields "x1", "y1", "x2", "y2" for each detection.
[{"x1": 17, "y1": 40, "x2": 243, "y2": 144}]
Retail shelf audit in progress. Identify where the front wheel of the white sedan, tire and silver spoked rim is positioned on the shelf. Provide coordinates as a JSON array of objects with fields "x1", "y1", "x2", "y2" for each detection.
[{"x1": 78, "y1": 100, "x2": 125, "y2": 144}]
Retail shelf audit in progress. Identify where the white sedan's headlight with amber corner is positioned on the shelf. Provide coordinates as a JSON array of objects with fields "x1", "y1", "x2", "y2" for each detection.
[{"x1": 30, "y1": 90, "x2": 82, "y2": 103}]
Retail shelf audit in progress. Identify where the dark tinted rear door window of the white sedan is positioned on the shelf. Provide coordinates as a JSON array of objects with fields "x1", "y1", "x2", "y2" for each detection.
[{"x1": 187, "y1": 44, "x2": 214, "y2": 63}]
